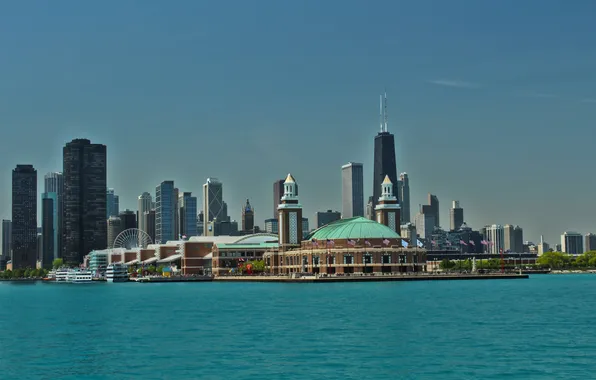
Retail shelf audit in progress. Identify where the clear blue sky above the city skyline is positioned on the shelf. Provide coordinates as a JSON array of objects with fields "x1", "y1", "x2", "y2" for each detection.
[{"x1": 0, "y1": 0, "x2": 596, "y2": 243}]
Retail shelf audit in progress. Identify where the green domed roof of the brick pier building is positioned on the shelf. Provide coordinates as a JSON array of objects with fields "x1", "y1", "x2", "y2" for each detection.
[{"x1": 306, "y1": 216, "x2": 400, "y2": 240}]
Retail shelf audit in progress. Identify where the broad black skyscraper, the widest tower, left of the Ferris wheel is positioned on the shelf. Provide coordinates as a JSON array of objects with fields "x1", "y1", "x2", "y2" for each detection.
[{"x1": 62, "y1": 139, "x2": 107, "y2": 264}]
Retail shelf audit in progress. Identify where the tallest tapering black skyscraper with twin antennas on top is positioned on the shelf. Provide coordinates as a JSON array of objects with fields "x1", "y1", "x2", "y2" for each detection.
[{"x1": 373, "y1": 93, "x2": 400, "y2": 206}]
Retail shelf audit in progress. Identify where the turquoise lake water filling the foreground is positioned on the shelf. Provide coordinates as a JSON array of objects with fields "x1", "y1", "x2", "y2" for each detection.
[{"x1": 0, "y1": 275, "x2": 596, "y2": 380}]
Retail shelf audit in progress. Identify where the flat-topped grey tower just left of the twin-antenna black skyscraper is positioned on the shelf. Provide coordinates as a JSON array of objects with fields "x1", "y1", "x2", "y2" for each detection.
[{"x1": 341, "y1": 162, "x2": 364, "y2": 218}]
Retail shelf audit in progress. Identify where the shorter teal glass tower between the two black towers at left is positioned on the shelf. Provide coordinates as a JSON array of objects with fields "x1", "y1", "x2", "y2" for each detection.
[{"x1": 41, "y1": 192, "x2": 60, "y2": 268}]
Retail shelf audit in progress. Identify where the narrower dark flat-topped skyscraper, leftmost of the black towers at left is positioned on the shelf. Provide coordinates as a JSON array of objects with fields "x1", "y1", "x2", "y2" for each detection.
[{"x1": 12, "y1": 165, "x2": 37, "y2": 270}]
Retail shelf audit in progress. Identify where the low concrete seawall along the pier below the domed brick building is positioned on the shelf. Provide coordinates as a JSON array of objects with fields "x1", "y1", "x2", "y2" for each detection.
[{"x1": 213, "y1": 273, "x2": 530, "y2": 283}]
